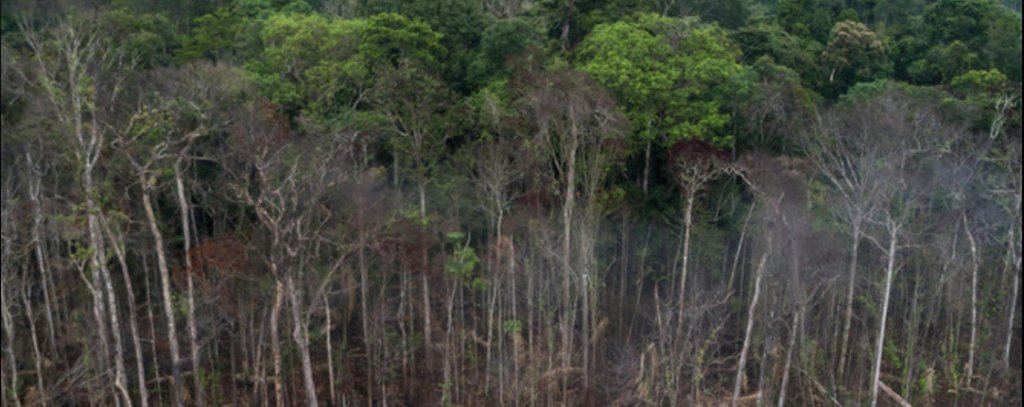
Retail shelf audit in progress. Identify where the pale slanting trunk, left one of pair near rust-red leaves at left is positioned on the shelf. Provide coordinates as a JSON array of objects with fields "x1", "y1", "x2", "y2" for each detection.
[{"x1": 138, "y1": 170, "x2": 184, "y2": 407}]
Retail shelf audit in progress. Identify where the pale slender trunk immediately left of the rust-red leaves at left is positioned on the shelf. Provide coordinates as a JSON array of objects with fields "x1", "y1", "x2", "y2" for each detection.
[{"x1": 174, "y1": 163, "x2": 206, "y2": 407}]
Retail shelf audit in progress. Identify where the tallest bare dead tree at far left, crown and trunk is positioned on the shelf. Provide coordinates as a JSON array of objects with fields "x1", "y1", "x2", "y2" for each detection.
[{"x1": 22, "y1": 17, "x2": 131, "y2": 404}]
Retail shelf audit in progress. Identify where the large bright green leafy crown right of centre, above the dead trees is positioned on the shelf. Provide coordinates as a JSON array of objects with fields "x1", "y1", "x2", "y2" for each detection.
[{"x1": 580, "y1": 14, "x2": 742, "y2": 148}]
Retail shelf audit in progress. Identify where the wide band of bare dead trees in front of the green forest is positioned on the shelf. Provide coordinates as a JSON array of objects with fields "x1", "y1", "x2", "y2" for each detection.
[{"x1": 2, "y1": 14, "x2": 1021, "y2": 406}]
